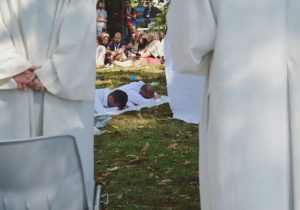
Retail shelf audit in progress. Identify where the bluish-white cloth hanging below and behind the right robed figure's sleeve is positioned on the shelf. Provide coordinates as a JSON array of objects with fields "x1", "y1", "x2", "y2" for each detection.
[{"x1": 164, "y1": 39, "x2": 204, "y2": 123}]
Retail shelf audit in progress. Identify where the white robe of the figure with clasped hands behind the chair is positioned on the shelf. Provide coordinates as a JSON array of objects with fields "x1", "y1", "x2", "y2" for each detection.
[{"x1": 0, "y1": 0, "x2": 96, "y2": 209}]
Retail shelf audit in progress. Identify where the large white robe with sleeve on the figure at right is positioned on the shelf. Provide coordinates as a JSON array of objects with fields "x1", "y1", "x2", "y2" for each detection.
[{"x1": 167, "y1": 0, "x2": 300, "y2": 210}]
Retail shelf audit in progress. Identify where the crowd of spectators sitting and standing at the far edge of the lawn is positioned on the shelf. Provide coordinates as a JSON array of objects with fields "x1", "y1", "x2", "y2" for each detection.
[{"x1": 96, "y1": 0, "x2": 164, "y2": 68}]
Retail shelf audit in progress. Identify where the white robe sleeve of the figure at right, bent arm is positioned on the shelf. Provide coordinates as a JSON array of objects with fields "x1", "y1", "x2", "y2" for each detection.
[{"x1": 167, "y1": 0, "x2": 216, "y2": 75}]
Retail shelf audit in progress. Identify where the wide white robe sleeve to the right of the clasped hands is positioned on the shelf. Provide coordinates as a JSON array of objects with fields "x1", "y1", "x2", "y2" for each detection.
[{"x1": 36, "y1": 0, "x2": 96, "y2": 100}]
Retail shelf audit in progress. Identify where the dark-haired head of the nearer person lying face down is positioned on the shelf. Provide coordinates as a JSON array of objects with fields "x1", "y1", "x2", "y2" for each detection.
[{"x1": 107, "y1": 90, "x2": 128, "y2": 109}]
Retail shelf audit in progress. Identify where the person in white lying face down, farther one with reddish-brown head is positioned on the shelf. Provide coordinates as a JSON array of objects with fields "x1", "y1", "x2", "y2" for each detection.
[{"x1": 117, "y1": 81, "x2": 160, "y2": 106}]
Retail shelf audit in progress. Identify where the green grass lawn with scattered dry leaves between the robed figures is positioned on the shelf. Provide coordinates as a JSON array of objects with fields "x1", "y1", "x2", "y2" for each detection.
[{"x1": 94, "y1": 66, "x2": 200, "y2": 210}]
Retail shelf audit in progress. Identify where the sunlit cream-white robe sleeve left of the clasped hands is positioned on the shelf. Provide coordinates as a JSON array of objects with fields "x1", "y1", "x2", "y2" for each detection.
[{"x1": 0, "y1": 12, "x2": 32, "y2": 90}]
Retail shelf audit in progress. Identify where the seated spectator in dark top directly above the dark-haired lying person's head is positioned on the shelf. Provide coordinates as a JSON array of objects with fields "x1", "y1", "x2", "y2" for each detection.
[{"x1": 108, "y1": 32, "x2": 127, "y2": 61}]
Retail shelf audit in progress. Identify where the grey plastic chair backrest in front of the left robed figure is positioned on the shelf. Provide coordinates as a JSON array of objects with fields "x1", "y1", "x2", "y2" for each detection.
[{"x1": 0, "y1": 136, "x2": 88, "y2": 210}]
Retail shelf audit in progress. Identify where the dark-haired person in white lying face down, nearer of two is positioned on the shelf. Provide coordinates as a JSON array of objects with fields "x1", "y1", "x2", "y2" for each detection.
[{"x1": 94, "y1": 88, "x2": 128, "y2": 113}]
